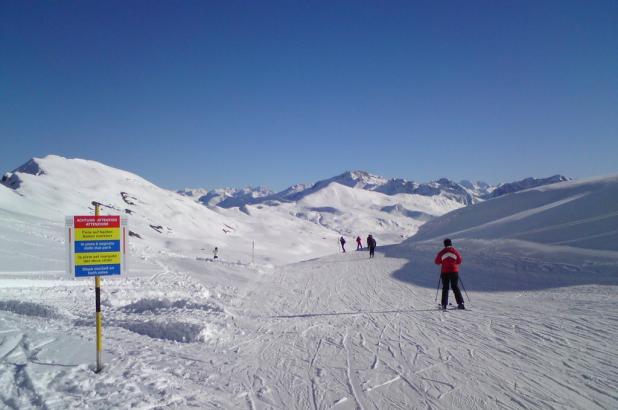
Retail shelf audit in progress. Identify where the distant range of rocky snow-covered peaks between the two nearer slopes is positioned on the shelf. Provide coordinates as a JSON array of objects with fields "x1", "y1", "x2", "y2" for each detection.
[{"x1": 173, "y1": 171, "x2": 565, "y2": 243}]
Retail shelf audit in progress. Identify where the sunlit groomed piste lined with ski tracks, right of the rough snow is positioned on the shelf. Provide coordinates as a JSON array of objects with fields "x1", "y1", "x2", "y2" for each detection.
[{"x1": 209, "y1": 252, "x2": 618, "y2": 409}]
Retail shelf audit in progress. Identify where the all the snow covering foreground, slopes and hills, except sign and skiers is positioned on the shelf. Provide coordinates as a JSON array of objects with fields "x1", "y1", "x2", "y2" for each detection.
[{"x1": 0, "y1": 157, "x2": 618, "y2": 409}]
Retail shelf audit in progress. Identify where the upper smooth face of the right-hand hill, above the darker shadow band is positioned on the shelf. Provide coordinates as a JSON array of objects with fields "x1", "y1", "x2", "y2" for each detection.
[{"x1": 411, "y1": 176, "x2": 618, "y2": 251}]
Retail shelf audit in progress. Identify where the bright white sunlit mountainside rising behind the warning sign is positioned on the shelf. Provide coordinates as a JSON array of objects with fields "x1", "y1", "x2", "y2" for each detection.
[{"x1": 0, "y1": 155, "x2": 338, "y2": 263}]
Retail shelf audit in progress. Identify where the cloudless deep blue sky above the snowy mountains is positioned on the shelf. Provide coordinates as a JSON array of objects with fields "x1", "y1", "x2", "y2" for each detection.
[{"x1": 0, "y1": 0, "x2": 618, "y2": 189}]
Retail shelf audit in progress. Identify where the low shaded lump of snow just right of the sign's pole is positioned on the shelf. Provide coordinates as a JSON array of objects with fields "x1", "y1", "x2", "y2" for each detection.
[{"x1": 116, "y1": 320, "x2": 212, "y2": 343}]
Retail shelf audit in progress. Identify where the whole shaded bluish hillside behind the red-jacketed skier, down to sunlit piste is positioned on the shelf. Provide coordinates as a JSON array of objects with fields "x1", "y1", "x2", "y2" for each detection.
[{"x1": 389, "y1": 176, "x2": 618, "y2": 291}]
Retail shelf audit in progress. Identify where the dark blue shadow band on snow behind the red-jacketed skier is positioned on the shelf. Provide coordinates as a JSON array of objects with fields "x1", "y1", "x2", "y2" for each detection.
[{"x1": 380, "y1": 240, "x2": 618, "y2": 292}]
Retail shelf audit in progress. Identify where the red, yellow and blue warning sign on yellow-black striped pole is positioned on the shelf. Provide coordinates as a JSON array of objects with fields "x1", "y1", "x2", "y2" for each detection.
[{"x1": 67, "y1": 202, "x2": 127, "y2": 373}]
